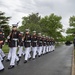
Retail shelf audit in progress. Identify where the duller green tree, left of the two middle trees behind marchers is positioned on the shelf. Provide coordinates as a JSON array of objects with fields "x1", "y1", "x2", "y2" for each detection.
[{"x1": 19, "y1": 13, "x2": 41, "y2": 33}]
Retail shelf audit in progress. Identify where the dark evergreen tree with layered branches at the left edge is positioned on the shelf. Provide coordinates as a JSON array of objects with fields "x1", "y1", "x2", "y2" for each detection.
[{"x1": 0, "y1": 11, "x2": 10, "y2": 37}]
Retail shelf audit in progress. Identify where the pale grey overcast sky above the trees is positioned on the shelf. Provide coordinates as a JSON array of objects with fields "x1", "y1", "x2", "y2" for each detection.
[{"x1": 0, "y1": 0, "x2": 75, "y2": 35}]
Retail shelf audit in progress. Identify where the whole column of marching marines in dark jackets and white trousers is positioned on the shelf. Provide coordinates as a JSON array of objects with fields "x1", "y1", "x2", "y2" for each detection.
[{"x1": 0, "y1": 24, "x2": 55, "y2": 71}]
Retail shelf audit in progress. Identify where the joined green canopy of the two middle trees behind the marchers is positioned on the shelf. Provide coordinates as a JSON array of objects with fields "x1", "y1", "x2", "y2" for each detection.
[{"x1": 19, "y1": 13, "x2": 63, "y2": 38}]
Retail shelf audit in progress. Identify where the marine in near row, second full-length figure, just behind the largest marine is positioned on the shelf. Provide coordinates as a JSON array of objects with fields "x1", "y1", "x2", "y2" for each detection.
[{"x1": 24, "y1": 29, "x2": 31, "y2": 63}]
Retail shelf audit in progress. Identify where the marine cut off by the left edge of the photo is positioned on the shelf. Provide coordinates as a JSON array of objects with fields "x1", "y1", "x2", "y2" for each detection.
[{"x1": 0, "y1": 28, "x2": 5, "y2": 71}]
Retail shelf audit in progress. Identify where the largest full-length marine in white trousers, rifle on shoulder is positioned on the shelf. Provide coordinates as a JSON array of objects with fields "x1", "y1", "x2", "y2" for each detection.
[{"x1": 7, "y1": 24, "x2": 20, "y2": 69}]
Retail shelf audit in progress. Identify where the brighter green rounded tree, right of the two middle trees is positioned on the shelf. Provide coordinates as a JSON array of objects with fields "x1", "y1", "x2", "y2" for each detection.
[{"x1": 40, "y1": 13, "x2": 63, "y2": 39}]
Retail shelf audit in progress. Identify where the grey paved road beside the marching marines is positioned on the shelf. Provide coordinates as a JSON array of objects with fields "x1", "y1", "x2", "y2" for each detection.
[{"x1": 0, "y1": 45, "x2": 73, "y2": 75}]
